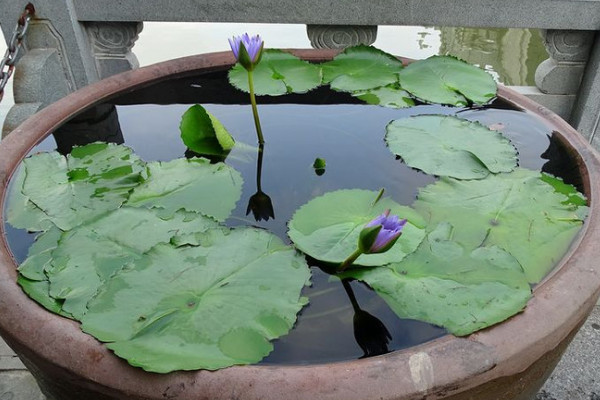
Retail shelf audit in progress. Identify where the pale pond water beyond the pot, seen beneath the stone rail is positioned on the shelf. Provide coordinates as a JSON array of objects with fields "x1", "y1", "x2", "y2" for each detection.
[{"x1": 0, "y1": 22, "x2": 548, "y2": 131}]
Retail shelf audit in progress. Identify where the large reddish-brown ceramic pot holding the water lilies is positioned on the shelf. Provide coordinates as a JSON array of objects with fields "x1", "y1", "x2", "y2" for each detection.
[{"x1": 0, "y1": 50, "x2": 600, "y2": 400}]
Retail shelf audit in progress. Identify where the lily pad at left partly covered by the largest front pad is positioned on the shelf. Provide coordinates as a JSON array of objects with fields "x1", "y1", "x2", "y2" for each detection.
[{"x1": 46, "y1": 207, "x2": 217, "y2": 319}]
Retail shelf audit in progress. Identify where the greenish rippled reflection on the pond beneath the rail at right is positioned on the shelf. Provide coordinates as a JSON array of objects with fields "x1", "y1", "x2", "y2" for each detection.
[{"x1": 439, "y1": 28, "x2": 548, "y2": 86}]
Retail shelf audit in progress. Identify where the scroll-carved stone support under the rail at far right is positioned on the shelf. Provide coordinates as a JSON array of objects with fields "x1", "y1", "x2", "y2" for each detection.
[{"x1": 535, "y1": 30, "x2": 594, "y2": 95}]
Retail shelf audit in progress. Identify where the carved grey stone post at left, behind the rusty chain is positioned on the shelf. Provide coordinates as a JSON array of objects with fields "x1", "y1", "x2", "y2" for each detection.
[{"x1": 0, "y1": 0, "x2": 142, "y2": 136}]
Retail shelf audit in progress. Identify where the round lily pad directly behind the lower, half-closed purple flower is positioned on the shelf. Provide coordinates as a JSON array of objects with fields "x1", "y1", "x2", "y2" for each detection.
[{"x1": 288, "y1": 189, "x2": 425, "y2": 266}]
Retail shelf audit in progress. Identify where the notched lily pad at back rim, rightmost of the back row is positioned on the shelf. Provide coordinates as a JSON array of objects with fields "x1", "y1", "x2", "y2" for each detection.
[{"x1": 400, "y1": 56, "x2": 497, "y2": 106}]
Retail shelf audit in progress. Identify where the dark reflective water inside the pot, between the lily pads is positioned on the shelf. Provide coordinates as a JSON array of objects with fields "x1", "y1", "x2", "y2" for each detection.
[{"x1": 6, "y1": 65, "x2": 577, "y2": 364}]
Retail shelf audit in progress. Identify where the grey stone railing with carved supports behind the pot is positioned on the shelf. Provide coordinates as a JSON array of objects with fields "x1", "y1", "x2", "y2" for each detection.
[{"x1": 0, "y1": 0, "x2": 600, "y2": 148}]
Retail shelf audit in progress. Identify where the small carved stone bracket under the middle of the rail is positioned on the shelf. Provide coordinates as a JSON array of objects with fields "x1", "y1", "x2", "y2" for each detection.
[{"x1": 306, "y1": 25, "x2": 377, "y2": 49}]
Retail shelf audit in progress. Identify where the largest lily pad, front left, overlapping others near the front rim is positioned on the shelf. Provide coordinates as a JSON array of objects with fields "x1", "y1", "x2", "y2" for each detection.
[{"x1": 82, "y1": 228, "x2": 310, "y2": 373}]
